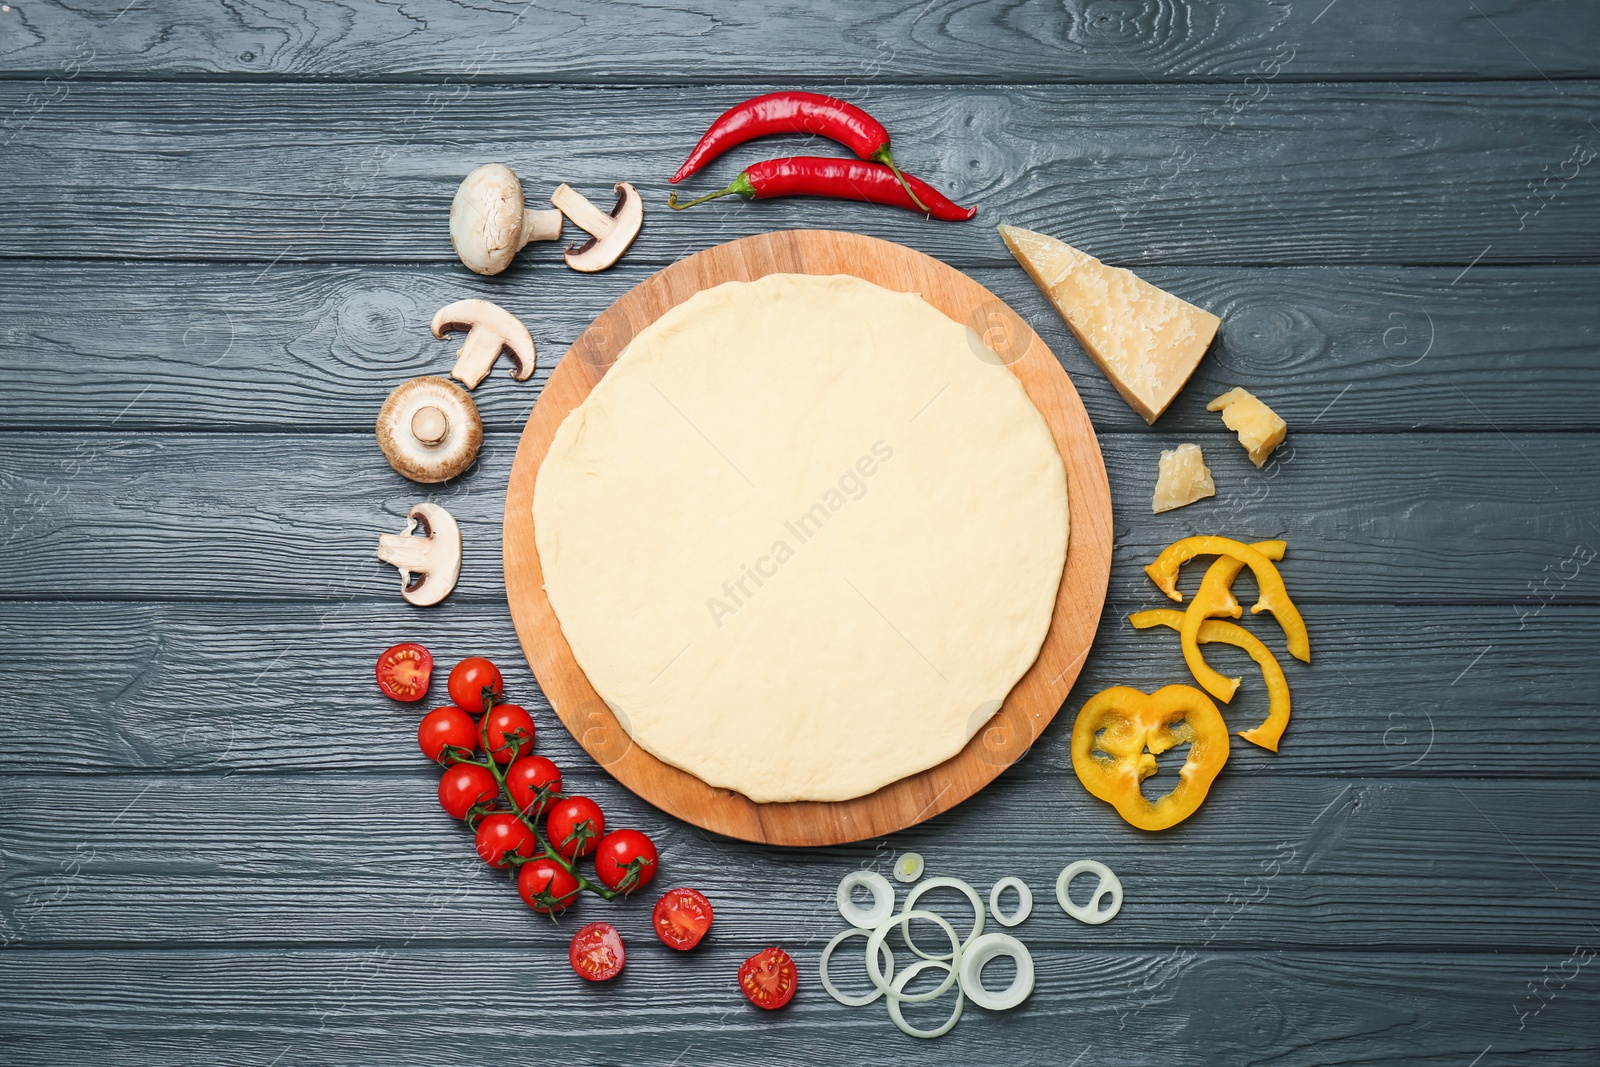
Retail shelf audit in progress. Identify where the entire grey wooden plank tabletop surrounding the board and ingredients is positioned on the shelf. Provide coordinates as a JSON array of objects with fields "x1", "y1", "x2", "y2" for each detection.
[{"x1": 0, "y1": 0, "x2": 1600, "y2": 1067}]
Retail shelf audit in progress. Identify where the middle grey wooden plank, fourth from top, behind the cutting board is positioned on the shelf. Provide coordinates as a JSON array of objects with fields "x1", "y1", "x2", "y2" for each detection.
[{"x1": 0, "y1": 428, "x2": 1600, "y2": 604}]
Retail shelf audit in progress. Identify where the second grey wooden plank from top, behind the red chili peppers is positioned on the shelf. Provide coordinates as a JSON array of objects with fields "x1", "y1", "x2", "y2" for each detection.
[{"x1": 0, "y1": 82, "x2": 1600, "y2": 267}]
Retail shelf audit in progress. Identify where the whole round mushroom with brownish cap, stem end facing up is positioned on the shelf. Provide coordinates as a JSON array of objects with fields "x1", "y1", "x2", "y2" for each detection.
[{"x1": 376, "y1": 376, "x2": 483, "y2": 483}]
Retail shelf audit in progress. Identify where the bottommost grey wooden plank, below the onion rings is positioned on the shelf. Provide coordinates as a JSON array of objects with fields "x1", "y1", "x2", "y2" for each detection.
[{"x1": 0, "y1": 940, "x2": 1600, "y2": 1067}]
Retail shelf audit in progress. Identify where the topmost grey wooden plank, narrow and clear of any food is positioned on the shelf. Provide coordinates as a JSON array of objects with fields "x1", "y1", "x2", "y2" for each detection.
[{"x1": 0, "y1": 0, "x2": 1600, "y2": 85}]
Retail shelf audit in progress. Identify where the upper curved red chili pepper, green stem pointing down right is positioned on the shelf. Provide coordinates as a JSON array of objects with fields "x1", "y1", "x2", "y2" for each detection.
[{"x1": 669, "y1": 91, "x2": 926, "y2": 213}]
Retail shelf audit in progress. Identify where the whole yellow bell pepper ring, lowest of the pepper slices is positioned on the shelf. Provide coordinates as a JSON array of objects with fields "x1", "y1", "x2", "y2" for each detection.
[{"x1": 1072, "y1": 685, "x2": 1227, "y2": 830}]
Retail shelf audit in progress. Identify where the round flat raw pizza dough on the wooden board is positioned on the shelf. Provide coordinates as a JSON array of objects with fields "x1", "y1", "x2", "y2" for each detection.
[{"x1": 533, "y1": 274, "x2": 1067, "y2": 803}]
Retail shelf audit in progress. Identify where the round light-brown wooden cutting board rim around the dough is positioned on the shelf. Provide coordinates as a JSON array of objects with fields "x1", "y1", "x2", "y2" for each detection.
[{"x1": 504, "y1": 230, "x2": 1112, "y2": 845}]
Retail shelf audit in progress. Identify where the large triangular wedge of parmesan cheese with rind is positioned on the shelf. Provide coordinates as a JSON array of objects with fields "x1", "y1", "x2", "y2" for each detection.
[{"x1": 1000, "y1": 226, "x2": 1222, "y2": 422}]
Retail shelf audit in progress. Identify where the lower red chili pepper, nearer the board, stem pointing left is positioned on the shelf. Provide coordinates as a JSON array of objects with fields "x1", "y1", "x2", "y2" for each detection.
[{"x1": 667, "y1": 155, "x2": 978, "y2": 222}]
